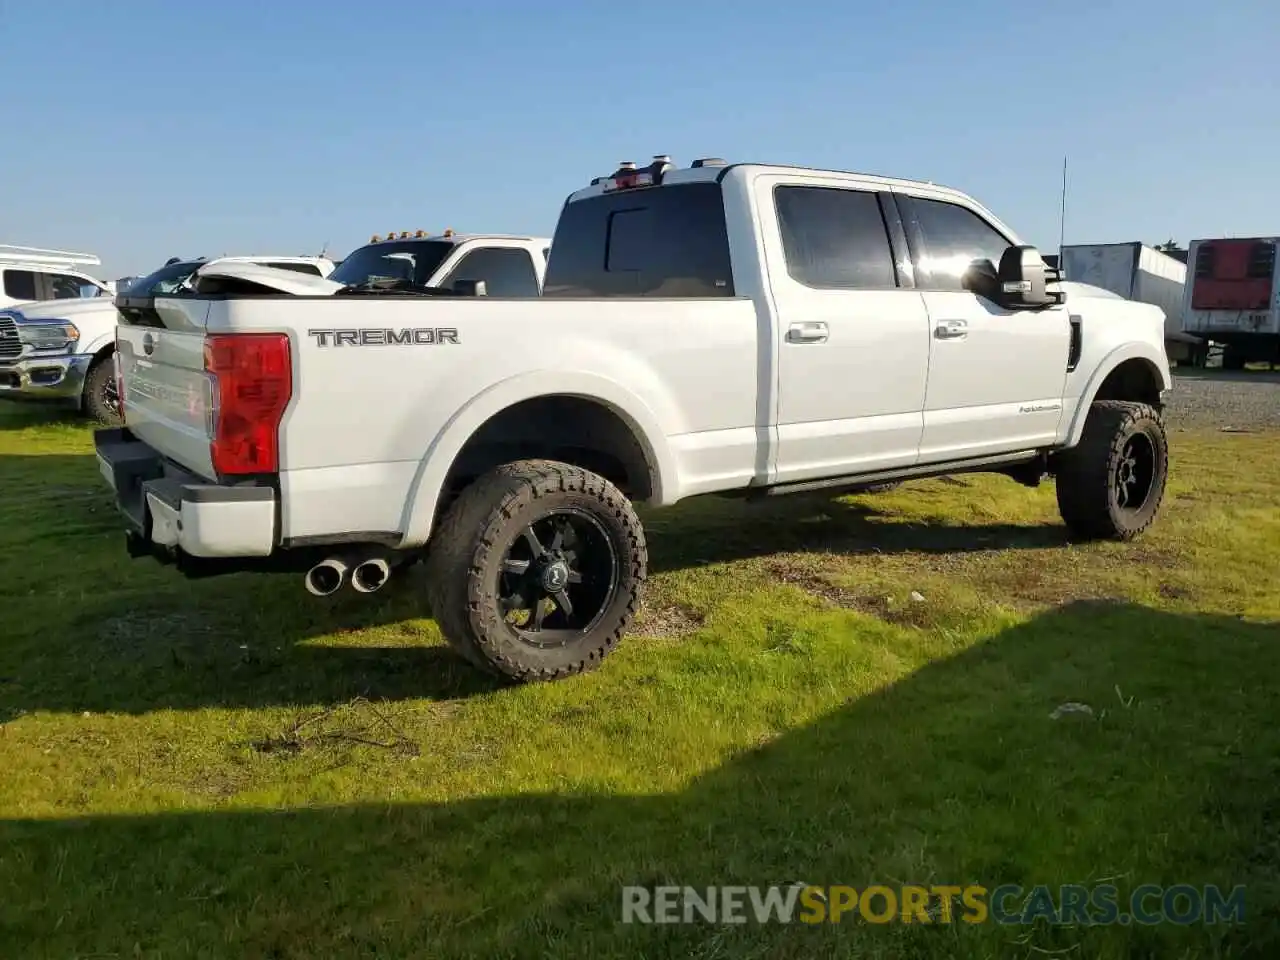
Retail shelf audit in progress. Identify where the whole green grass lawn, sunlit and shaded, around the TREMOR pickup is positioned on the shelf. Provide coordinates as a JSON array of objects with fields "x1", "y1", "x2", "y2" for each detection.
[{"x1": 0, "y1": 404, "x2": 1280, "y2": 960}]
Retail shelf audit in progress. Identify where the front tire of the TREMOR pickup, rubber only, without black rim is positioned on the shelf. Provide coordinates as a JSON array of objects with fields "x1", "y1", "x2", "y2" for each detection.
[{"x1": 1053, "y1": 401, "x2": 1169, "y2": 540}]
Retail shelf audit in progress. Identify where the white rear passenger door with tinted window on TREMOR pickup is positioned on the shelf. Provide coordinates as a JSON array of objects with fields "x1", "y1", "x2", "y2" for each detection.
[{"x1": 755, "y1": 174, "x2": 929, "y2": 483}]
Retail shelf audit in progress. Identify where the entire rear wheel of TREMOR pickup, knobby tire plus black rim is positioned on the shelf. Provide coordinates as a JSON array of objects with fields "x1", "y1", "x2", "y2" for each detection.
[{"x1": 426, "y1": 460, "x2": 648, "y2": 681}]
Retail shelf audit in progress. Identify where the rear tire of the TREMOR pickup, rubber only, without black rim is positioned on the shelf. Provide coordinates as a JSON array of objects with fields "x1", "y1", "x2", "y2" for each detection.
[{"x1": 425, "y1": 460, "x2": 648, "y2": 682}]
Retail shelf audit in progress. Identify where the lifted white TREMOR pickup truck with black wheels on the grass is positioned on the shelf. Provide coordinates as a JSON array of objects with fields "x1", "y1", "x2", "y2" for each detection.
[{"x1": 96, "y1": 157, "x2": 1171, "y2": 680}]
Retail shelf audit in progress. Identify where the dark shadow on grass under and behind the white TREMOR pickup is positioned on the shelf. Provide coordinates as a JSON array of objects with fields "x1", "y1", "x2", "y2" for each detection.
[{"x1": 0, "y1": 454, "x2": 1065, "y2": 721}]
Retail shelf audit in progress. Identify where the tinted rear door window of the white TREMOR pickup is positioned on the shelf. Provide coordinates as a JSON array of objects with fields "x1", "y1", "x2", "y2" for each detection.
[{"x1": 773, "y1": 187, "x2": 897, "y2": 291}]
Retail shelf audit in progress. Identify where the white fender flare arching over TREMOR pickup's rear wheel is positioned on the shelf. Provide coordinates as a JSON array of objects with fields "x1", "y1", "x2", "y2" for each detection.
[{"x1": 401, "y1": 370, "x2": 680, "y2": 548}]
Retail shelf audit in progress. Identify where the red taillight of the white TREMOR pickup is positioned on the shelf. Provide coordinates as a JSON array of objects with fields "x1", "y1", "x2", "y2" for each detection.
[{"x1": 205, "y1": 333, "x2": 293, "y2": 474}]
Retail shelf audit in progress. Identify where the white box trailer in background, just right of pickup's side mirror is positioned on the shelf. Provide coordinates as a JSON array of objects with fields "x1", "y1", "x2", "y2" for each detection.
[{"x1": 1060, "y1": 241, "x2": 1208, "y2": 366}]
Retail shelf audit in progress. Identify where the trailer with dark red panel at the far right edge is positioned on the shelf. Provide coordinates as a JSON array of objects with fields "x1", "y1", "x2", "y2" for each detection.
[{"x1": 1183, "y1": 237, "x2": 1280, "y2": 370}]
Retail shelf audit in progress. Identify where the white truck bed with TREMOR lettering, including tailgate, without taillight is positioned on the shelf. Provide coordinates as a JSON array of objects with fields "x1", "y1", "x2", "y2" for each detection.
[{"x1": 119, "y1": 296, "x2": 768, "y2": 540}]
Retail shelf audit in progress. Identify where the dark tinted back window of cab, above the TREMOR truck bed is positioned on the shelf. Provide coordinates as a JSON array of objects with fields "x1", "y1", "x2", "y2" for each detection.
[{"x1": 543, "y1": 183, "x2": 733, "y2": 297}]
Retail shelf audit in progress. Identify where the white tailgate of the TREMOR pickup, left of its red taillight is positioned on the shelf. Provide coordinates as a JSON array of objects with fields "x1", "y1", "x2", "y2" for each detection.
[{"x1": 116, "y1": 297, "x2": 216, "y2": 480}]
